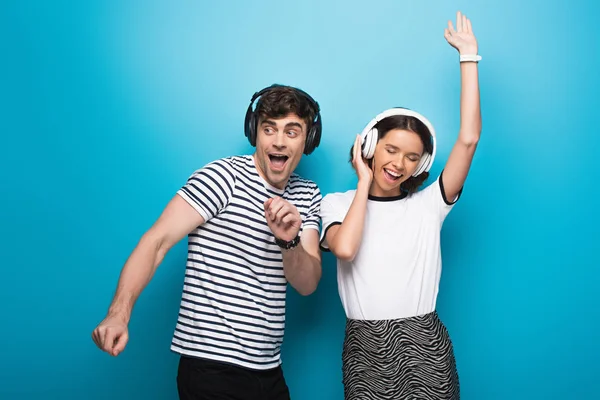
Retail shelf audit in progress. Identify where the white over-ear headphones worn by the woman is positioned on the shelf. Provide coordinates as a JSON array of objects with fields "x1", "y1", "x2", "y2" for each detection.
[{"x1": 360, "y1": 107, "x2": 437, "y2": 176}]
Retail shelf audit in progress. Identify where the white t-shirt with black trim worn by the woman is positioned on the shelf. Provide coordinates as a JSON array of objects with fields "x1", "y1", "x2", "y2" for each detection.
[{"x1": 321, "y1": 175, "x2": 462, "y2": 320}]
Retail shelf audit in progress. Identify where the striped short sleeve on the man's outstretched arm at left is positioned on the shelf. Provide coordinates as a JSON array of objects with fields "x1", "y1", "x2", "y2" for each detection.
[{"x1": 177, "y1": 159, "x2": 235, "y2": 221}]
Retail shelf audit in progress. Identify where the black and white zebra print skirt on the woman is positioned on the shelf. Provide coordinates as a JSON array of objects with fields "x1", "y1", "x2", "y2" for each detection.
[{"x1": 342, "y1": 311, "x2": 460, "y2": 400}]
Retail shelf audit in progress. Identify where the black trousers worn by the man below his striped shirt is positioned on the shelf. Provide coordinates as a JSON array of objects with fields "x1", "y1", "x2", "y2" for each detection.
[{"x1": 177, "y1": 356, "x2": 290, "y2": 400}]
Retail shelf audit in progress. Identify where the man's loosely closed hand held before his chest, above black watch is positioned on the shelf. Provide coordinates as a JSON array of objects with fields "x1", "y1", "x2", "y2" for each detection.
[{"x1": 264, "y1": 197, "x2": 302, "y2": 241}]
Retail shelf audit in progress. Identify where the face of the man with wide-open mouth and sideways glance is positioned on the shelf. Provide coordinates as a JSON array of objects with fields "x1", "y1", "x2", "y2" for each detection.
[{"x1": 254, "y1": 113, "x2": 307, "y2": 189}]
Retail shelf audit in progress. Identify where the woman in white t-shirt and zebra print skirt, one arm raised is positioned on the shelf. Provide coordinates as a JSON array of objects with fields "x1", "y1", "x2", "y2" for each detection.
[{"x1": 321, "y1": 12, "x2": 481, "y2": 400}]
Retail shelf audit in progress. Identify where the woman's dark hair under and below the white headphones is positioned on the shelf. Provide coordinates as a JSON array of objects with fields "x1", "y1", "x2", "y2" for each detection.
[{"x1": 350, "y1": 115, "x2": 433, "y2": 194}]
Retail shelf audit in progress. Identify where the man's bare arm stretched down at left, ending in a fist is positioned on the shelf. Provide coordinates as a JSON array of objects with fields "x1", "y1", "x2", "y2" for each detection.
[{"x1": 92, "y1": 195, "x2": 204, "y2": 356}]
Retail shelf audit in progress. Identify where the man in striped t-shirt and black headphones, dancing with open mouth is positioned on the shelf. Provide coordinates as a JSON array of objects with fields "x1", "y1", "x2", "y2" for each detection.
[{"x1": 92, "y1": 85, "x2": 321, "y2": 400}]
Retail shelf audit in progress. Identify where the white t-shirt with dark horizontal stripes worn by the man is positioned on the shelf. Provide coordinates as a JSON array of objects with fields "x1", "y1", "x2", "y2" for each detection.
[{"x1": 171, "y1": 156, "x2": 321, "y2": 370}]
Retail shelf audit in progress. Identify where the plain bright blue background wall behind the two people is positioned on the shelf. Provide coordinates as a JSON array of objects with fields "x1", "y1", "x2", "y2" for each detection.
[{"x1": 0, "y1": 0, "x2": 600, "y2": 400}]
